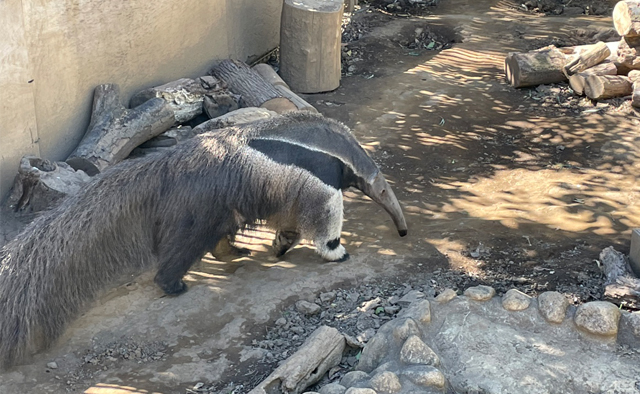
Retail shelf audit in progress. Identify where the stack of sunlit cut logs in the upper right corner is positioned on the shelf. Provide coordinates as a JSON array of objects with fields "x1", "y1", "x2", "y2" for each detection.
[{"x1": 504, "y1": 0, "x2": 640, "y2": 108}]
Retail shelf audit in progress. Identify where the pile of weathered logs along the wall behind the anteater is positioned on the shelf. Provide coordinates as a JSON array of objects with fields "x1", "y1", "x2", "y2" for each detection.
[{"x1": 7, "y1": 59, "x2": 317, "y2": 212}]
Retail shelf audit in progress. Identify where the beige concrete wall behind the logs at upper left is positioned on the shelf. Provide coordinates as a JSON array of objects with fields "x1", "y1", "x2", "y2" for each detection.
[{"x1": 0, "y1": 0, "x2": 282, "y2": 198}]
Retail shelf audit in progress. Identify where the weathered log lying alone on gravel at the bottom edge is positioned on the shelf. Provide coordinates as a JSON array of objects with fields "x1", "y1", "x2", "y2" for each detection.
[{"x1": 249, "y1": 326, "x2": 345, "y2": 394}]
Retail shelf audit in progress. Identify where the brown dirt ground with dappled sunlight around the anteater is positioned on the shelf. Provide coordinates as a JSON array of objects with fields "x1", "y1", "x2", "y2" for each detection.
[{"x1": 0, "y1": 0, "x2": 640, "y2": 393}]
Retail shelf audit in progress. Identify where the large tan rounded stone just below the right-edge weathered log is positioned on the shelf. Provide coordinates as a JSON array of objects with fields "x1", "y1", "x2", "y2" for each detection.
[{"x1": 573, "y1": 301, "x2": 620, "y2": 336}]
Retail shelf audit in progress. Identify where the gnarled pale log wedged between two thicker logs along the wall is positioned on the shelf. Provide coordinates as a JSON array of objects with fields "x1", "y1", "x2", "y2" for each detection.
[{"x1": 130, "y1": 76, "x2": 224, "y2": 124}]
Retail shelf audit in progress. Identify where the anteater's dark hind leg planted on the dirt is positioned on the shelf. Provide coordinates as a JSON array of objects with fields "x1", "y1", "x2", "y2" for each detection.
[{"x1": 154, "y1": 217, "x2": 228, "y2": 295}]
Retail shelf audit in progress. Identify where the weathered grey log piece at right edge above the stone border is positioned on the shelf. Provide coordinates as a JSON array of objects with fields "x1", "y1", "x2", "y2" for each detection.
[{"x1": 600, "y1": 246, "x2": 640, "y2": 309}]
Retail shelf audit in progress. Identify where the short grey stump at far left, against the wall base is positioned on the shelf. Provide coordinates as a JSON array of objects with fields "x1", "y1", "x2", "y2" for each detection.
[{"x1": 7, "y1": 156, "x2": 91, "y2": 213}]
